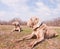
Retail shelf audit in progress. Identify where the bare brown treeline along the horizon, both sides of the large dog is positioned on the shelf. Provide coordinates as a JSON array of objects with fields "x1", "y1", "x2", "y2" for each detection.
[{"x1": 0, "y1": 17, "x2": 60, "y2": 26}]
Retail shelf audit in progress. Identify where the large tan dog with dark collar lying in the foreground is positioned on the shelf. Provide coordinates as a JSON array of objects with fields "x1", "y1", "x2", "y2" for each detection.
[{"x1": 17, "y1": 17, "x2": 58, "y2": 48}]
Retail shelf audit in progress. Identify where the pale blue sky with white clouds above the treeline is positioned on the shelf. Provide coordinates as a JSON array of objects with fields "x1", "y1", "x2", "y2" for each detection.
[{"x1": 0, "y1": 0, "x2": 60, "y2": 21}]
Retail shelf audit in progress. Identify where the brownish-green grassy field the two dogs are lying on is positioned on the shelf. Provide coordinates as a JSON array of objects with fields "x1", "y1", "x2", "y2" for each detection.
[{"x1": 0, "y1": 25, "x2": 60, "y2": 49}]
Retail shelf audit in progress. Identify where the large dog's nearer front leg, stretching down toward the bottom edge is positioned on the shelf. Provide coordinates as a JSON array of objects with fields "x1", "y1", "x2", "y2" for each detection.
[{"x1": 29, "y1": 30, "x2": 44, "y2": 48}]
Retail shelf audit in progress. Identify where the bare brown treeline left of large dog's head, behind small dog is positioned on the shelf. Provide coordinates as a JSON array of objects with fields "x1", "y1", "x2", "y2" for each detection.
[{"x1": 0, "y1": 18, "x2": 26, "y2": 25}]
